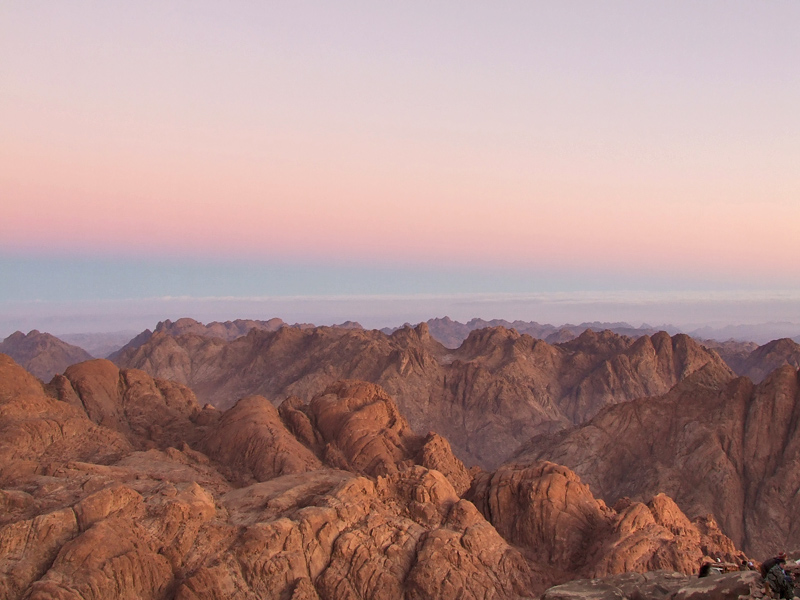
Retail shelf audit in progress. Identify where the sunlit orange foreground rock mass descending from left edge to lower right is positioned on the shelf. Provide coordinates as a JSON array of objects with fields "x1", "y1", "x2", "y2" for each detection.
[{"x1": 0, "y1": 355, "x2": 743, "y2": 600}]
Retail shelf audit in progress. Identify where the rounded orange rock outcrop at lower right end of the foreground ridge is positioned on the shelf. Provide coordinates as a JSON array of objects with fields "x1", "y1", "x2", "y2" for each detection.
[{"x1": 467, "y1": 462, "x2": 741, "y2": 581}]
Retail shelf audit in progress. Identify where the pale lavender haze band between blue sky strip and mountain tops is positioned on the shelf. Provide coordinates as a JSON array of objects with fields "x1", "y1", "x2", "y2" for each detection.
[{"x1": 0, "y1": 292, "x2": 800, "y2": 343}]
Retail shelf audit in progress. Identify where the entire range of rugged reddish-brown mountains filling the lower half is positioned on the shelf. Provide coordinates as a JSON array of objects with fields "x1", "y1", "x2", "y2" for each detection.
[{"x1": 0, "y1": 319, "x2": 800, "y2": 600}]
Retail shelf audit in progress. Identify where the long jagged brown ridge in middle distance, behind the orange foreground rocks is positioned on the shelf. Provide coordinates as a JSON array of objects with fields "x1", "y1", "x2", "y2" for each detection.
[{"x1": 111, "y1": 324, "x2": 727, "y2": 468}]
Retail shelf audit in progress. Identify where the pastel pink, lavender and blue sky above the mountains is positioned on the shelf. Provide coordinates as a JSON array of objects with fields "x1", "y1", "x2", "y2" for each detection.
[{"x1": 0, "y1": 0, "x2": 800, "y2": 334}]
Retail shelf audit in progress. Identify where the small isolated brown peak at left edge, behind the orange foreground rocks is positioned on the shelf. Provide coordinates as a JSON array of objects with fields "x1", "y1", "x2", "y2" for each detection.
[{"x1": 0, "y1": 329, "x2": 92, "y2": 381}]
